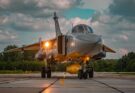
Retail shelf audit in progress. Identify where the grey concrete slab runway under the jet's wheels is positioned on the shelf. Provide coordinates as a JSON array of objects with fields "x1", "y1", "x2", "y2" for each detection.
[{"x1": 0, "y1": 73, "x2": 135, "y2": 93}]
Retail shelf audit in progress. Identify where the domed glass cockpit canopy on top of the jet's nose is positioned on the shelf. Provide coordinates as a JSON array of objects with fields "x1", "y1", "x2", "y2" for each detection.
[{"x1": 72, "y1": 24, "x2": 93, "y2": 33}]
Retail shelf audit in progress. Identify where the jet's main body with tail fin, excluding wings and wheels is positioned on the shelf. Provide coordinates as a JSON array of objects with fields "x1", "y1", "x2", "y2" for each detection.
[{"x1": 37, "y1": 13, "x2": 106, "y2": 59}]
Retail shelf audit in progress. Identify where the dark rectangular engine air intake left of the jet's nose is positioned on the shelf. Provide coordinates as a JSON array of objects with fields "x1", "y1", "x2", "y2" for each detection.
[{"x1": 57, "y1": 35, "x2": 67, "y2": 55}]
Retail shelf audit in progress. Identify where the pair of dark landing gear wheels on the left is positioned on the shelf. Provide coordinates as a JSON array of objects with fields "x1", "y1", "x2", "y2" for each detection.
[{"x1": 41, "y1": 67, "x2": 51, "y2": 78}]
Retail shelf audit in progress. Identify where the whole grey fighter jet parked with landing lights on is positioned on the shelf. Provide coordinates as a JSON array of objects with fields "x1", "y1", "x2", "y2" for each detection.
[{"x1": 6, "y1": 12, "x2": 115, "y2": 79}]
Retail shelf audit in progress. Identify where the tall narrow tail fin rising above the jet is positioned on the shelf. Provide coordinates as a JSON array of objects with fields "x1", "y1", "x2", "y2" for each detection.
[{"x1": 53, "y1": 12, "x2": 62, "y2": 37}]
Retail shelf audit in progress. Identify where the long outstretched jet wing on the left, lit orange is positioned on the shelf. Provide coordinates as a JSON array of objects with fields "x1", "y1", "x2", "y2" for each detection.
[{"x1": 4, "y1": 38, "x2": 56, "y2": 53}]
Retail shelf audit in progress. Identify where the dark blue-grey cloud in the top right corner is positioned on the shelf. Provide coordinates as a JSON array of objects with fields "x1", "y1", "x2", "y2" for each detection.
[{"x1": 109, "y1": 0, "x2": 135, "y2": 21}]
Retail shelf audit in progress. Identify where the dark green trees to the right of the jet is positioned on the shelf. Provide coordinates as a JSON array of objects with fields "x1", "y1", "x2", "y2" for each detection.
[{"x1": 94, "y1": 52, "x2": 135, "y2": 72}]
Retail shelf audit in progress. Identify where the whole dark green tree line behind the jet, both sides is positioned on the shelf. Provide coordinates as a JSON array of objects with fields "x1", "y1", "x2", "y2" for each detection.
[{"x1": 0, "y1": 45, "x2": 135, "y2": 72}]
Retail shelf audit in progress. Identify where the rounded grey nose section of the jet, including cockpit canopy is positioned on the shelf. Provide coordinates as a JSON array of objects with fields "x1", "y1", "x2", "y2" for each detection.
[{"x1": 67, "y1": 24, "x2": 102, "y2": 57}]
